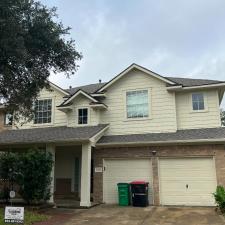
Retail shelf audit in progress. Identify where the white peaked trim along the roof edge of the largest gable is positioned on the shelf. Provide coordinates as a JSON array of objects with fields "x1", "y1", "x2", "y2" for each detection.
[{"x1": 98, "y1": 64, "x2": 176, "y2": 92}]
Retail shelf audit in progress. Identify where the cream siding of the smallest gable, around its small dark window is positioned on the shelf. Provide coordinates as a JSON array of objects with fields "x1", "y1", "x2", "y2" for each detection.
[{"x1": 67, "y1": 95, "x2": 99, "y2": 127}]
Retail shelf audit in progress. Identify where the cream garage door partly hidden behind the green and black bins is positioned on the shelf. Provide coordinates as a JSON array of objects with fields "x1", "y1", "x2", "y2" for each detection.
[{"x1": 103, "y1": 159, "x2": 152, "y2": 204}]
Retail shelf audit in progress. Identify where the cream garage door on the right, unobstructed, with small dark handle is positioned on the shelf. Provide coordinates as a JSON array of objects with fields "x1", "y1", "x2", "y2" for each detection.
[{"x1": 159, "y1": 158, "x2": 216, "y2": 206}]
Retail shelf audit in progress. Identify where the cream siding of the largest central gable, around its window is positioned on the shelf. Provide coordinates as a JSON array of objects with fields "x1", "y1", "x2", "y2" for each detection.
[{"x1": 101, "y1": 70, "x2": 177, "y2": 135}]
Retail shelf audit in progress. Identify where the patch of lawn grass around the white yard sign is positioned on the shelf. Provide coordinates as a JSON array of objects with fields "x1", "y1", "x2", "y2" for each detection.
[{"x1": 0, "y1": 208, "x2": 49, "y2": 225}]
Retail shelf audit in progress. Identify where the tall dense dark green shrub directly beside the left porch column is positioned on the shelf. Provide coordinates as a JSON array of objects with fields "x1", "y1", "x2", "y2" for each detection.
[{"x1": 17, "y1": 149, "x2": 53, "y2": 204}]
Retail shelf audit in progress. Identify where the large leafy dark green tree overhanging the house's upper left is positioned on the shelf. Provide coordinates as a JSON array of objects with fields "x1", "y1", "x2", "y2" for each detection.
[{"x1": 0, "y1": 0, "x2": 82, "y2": 120}]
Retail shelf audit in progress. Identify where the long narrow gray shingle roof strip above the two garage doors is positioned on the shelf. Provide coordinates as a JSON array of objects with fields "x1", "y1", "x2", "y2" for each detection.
[{"x1": 96, "y1": 127, "x2": 225, "y2": 147}]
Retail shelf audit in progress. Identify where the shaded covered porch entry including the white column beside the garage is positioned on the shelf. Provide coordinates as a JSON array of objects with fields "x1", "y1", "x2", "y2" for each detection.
[{"x1": 46, "y1": 143, "x2": 92, "y2": 207}]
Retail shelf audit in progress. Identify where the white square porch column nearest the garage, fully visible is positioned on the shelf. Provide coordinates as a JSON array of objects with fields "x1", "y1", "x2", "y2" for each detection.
[{"x1": 80, "y1": 143, "x2": 91, "y2": 207}]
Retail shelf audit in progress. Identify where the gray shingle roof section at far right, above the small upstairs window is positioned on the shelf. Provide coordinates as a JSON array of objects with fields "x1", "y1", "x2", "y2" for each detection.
[{"x1": 165, "y1": 77, "x2": 224, "y2": 87}]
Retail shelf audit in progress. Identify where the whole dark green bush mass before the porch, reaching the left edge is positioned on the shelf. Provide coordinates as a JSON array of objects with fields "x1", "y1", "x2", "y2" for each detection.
[{"x1": 0, "y1": 149, "x2": 53, "y2": 204}]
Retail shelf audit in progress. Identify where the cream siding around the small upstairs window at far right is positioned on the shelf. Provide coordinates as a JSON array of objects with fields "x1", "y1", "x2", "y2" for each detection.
[{"x1": 176, "y1": 90, "x2": 221, "y2": 129}]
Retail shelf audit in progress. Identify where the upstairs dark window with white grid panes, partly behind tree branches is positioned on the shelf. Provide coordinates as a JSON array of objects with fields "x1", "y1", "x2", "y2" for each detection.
[{"x1": 34, "y1": 99, "x2": 52, "y2": 124}]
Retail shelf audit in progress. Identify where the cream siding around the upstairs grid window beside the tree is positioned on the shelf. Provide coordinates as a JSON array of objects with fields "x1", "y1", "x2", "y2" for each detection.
[{"x1": 14, "y1": 88, "x2": 67, "y2": 129}]
